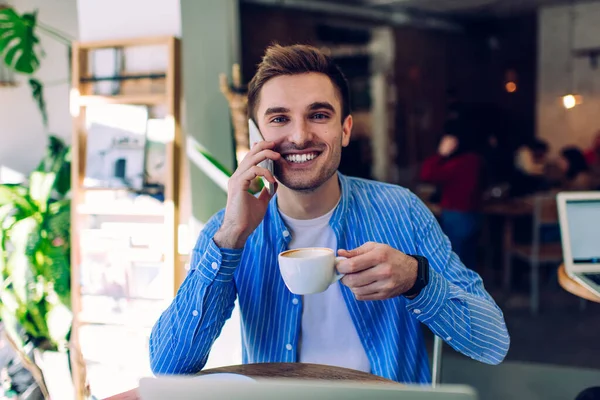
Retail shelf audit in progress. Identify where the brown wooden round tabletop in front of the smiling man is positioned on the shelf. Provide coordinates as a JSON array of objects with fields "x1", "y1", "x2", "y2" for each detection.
[{"x1": 105, "y1": 363, "x2": 398, "y2": 400}]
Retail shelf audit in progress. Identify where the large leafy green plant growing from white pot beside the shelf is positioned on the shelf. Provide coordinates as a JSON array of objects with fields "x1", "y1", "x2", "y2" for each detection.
[{"x1": 0, "y1": 136, "x2": 72, "y2": 396}]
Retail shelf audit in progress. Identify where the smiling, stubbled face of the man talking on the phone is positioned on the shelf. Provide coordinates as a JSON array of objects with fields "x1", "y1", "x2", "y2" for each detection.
[{"x1": 256, "y1": 73, "x2": 352, "y2": 191}]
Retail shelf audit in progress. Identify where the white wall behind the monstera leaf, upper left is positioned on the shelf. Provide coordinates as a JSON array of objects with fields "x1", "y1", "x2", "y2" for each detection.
[{"x1": 0, "y1": 0, "x2": 77, "y2": 182}]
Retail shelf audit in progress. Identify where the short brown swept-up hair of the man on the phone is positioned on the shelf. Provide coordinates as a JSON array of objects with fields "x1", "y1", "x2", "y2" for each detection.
[{"x1": 248, "y1": 44, "x2": 350, "y2": 123}]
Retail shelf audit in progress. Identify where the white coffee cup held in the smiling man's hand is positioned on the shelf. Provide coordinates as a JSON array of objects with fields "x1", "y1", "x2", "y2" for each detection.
[{"x1": 279, "y1": 247, "x2": 345, "y2": 294}]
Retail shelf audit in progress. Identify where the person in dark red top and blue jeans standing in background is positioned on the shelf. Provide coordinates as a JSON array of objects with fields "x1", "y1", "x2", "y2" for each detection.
[{"x1": 420, "y1": 128, "x2": 484, "y2": 269}]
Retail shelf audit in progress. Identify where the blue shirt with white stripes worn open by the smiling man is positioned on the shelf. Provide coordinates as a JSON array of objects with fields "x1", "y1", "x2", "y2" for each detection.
[{"x1": 150, "y1": 174, "x2": 510, "y2": 383}]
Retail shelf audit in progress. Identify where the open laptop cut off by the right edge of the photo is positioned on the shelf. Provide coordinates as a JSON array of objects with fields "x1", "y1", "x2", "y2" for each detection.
[{"x1": 557, "y1": 191, "x2": 600, "y2": 296}]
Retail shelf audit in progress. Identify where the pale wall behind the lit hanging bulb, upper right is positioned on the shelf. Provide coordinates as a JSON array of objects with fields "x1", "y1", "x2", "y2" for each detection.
[{"x1": 537, "y1": 3, "x2": 600, "y2": 153}]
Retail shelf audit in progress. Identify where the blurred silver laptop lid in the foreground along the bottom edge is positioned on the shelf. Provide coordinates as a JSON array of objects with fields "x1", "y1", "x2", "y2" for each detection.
[{"x1": 139, "y1": 376, "x2": 477, "y2": 400}]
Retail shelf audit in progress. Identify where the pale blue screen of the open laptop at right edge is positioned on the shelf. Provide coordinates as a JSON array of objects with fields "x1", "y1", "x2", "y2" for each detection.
[{"x1": 566, "y1": 199, "x2": 600, "y2": 264}]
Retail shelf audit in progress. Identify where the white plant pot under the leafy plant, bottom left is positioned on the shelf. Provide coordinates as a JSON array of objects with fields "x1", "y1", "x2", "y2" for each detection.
[{"x1": 34, "y1": 349, "x2": 75, "y2": 400}]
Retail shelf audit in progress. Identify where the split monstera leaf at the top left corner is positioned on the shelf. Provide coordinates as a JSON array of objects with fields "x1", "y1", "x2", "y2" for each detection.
[{"x1": 0, "y1": 8, "x2": 40, "y2": 75}]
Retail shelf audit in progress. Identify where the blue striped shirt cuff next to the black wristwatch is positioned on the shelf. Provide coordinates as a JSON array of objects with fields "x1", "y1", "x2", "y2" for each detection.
[{"x1": 406, "y1": 267, "x2": 450, "y2": 323}]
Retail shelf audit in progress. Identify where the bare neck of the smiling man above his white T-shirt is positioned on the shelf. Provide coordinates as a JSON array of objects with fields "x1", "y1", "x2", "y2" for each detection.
[{"x1": 277, "y1": 172, "x2": 342, "y2": 219}]
